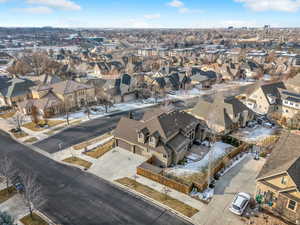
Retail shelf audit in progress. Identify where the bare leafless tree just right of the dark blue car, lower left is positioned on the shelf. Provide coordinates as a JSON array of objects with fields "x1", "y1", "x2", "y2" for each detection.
[{"x1": 20, "y1": 173, "x2": 46, "y2": 217}]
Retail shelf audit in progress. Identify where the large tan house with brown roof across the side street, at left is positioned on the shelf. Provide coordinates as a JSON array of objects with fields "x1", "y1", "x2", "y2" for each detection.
[{"x1": 18, "y1": 80, "x2": 95, "y2": 117}]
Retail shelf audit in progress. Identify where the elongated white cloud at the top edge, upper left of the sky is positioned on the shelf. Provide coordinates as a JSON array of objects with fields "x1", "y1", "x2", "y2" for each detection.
[{"x1": 27, "y1": 0, "x2": 81, "y2": 10}]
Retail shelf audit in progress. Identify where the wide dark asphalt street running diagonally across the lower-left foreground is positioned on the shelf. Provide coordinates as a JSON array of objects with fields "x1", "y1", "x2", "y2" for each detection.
[{"x1": 0, "y1": 131, "x2": 191, "y2": 225}]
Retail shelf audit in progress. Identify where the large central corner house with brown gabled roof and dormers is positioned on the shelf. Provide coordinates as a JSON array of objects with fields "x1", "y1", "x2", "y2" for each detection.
[{"x1": 114, "y1": 109, "x2": 206, "y2": 167}]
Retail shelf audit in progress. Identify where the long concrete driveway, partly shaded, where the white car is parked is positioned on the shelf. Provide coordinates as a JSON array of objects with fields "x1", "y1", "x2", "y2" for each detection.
[{"x1": 193, "y1": 156, "x2": 265, "y2": 225}]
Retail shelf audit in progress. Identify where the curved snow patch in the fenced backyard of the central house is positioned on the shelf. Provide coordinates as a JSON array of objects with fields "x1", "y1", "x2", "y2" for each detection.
[{"x1": 166, "y1": 142, "x2": 233, "y2": 176}]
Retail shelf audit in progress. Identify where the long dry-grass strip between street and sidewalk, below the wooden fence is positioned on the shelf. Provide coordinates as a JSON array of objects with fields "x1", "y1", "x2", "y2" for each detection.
[{"x1": 116, "y1": 177, "x2": 199, "y2": 217}]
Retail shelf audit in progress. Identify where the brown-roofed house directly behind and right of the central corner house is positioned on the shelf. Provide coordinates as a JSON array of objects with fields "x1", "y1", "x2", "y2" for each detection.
[{"x1": 190, "y1": 94, "x2": 255, "y2": 134}]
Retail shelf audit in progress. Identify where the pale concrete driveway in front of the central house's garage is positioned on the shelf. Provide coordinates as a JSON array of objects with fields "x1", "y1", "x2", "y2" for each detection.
[{"x1": 89, "y1": 147, "x2": 147, "y2": 181}]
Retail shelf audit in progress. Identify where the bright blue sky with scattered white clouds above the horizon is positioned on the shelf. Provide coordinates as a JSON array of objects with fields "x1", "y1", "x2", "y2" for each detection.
[{"x1": 0, "y1": 0, "x2": 300, "y2": 28}]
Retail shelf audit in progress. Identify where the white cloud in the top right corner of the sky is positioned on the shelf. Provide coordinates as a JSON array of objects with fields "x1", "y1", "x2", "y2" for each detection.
[{"x1": 234, "y1": 0, "x2": 300, "y2": 12}]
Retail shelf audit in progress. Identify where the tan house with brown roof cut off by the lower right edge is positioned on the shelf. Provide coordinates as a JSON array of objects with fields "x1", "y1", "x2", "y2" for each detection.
[{"x1": 256, "y1": 133, "x2": 300, "y2": 224}]
